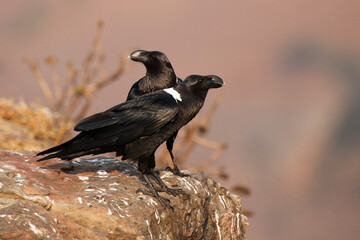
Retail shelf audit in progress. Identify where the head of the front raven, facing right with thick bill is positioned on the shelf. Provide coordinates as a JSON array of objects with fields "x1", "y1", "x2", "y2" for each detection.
[{"x1": 183, "y1": 75, "x2": 224, "y2": 92}]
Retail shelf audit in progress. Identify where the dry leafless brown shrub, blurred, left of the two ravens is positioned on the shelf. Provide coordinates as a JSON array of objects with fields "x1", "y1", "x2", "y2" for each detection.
[{"x1": 25, "y1": 21, "x2": 135, "y2": 121}]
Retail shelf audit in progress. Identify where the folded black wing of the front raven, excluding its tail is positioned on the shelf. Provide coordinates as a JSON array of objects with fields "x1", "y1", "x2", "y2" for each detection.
[{"x1": 74, "y1": 91, "x2": 178, "y2": 145}]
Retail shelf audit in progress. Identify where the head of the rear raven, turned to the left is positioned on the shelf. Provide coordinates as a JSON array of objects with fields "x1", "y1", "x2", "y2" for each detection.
[{"x1": 129, "y1": 50, "x2": 172, "y2": 70}]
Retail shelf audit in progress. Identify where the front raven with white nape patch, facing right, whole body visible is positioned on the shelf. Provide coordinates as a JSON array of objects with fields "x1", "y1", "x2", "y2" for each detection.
[{"x1": 37, "y1": 75, "x2": 223, "y2": 206}]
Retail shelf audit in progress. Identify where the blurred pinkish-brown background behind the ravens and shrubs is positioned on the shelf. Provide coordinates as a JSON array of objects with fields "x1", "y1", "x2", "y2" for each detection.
[{"x1": 0, "y1": 0, "x2": 360, "y2": 240}]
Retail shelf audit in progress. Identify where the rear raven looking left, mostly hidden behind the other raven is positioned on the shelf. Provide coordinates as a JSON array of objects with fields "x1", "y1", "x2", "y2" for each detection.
[{"x1": 126, "y1": 50, "x2": 187, "y2": 176}]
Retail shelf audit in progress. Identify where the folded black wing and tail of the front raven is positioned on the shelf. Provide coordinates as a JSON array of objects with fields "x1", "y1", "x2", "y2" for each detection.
[{"x1": 37, "y1": 91, "x2": 179, "y2": 161}]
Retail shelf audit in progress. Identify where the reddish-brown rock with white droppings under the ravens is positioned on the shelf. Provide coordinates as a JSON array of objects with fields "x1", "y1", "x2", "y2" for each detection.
[{"x1": 0, "y1": 151, "x2": 248, "y2": 240}]
